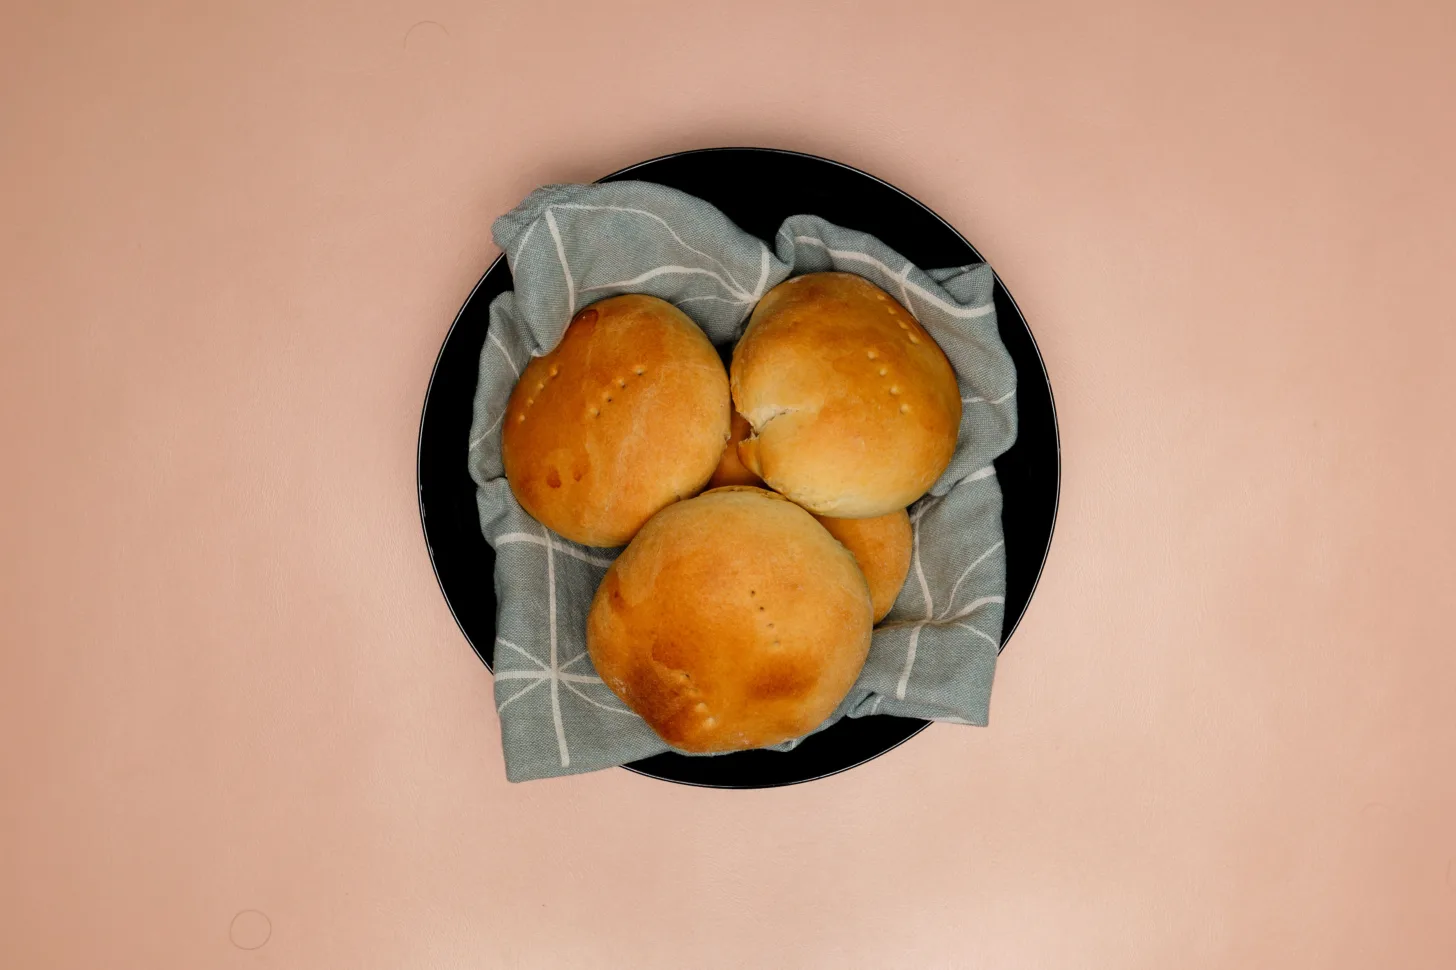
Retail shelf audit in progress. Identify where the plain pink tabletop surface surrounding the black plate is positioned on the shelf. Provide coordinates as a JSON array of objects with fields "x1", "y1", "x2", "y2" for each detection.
[{"x1": 0, "y1": 0, "x2": 1456, "y2": 970}]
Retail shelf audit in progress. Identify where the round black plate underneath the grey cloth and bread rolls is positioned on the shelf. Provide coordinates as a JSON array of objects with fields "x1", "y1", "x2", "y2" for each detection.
[{"x1": 419, "y1": 149, "x2": 1061, "y2": 788}]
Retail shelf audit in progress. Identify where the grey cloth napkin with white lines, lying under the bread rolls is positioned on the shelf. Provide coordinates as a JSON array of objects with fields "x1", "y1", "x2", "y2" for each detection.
[{"x1": 469, "y1": 182, "x2": 1016, "y2": 781}]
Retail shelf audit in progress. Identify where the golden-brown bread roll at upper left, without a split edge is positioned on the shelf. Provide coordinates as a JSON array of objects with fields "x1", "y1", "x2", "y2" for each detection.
[{"x1": 501, "y1": 294, "x2": 731, "y2": 546}]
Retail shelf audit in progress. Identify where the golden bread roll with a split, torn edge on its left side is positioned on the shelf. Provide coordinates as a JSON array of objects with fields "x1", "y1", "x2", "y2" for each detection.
[{"x1": 731, "y1": 272, "x2": 961, "y2": 518}]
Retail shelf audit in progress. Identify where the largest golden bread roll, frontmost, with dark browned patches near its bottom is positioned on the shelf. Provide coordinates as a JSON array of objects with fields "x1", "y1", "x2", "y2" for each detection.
[{"x1": 587, "y1": 486, "x2": 872, "y2": 752}]
